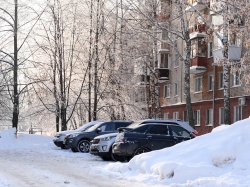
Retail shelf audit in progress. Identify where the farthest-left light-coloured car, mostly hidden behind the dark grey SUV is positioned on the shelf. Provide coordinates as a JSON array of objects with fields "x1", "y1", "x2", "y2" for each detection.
[{"x1": 53, "y1": 121, "x2": 101, "y2": 149}]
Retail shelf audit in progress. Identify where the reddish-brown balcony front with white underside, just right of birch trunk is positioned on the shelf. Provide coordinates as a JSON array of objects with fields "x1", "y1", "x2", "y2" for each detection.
[{"x1": 190, "y1": 56, "x2": 207, "y2": 74}]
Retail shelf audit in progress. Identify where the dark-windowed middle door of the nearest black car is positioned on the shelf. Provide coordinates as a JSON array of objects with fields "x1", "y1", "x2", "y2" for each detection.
[{"x1": 146, "y1": 124, "x2": 174, "y2": 150}]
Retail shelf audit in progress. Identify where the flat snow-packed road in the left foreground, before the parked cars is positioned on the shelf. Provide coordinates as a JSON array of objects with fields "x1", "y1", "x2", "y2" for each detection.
[{"x1": 0, "y1": 149, "x2": 164, "y2": 187}]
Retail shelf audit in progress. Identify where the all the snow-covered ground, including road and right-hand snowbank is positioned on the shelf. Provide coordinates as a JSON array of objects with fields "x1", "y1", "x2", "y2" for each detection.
[{"x1": 0, "y1": 118, "x2": 250, "y2": 187}]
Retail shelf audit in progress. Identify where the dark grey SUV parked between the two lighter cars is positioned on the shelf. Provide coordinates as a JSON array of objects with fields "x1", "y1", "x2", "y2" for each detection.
[{"x1": 65, "y1": 120, "x2": 133, "y2": 153}]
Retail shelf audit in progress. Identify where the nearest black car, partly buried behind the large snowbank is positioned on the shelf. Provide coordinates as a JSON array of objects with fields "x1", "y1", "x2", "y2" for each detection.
[{"x1": 112, "y1": 122, "x2": 195, "y2": 159}]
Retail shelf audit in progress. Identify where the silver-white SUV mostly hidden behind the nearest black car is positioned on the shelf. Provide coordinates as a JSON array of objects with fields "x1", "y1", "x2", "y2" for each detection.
[{"x1": 90, "y1": 119, "x2": 197, "y2": 161}]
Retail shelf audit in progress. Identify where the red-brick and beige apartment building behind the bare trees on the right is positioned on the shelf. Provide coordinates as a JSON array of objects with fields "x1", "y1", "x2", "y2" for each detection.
[{"x1": 156, "y1": 0, "x2": 250, "y2": 134}]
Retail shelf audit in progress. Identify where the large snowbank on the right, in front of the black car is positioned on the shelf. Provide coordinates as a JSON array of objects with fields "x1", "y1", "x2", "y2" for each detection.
[{"x1": 106, "y1": 118, "x2": 250, "y2": 187}]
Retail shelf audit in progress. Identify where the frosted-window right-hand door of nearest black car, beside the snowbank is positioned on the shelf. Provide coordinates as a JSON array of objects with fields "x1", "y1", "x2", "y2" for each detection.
[{"x1": 169, "y1": 125, "x2": 192, "y2": 144}]
